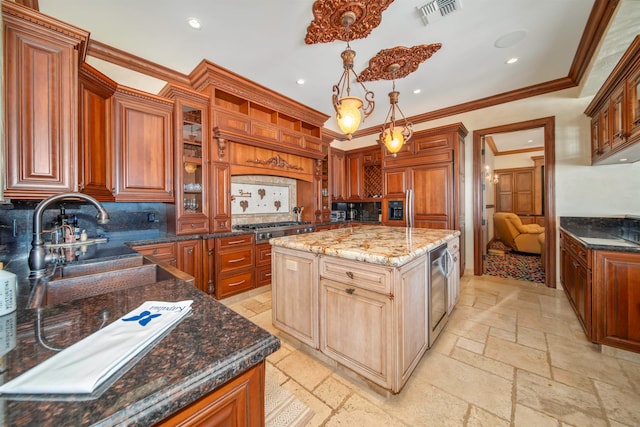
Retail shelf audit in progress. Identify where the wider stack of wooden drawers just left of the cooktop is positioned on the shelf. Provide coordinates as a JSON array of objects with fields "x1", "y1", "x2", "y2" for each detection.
[{"x1": 214, "y1": 234, "x2": 255, "y2": 299}]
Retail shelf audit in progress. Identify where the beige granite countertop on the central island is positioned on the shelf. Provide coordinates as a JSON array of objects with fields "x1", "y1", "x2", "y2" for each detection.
[{"x1": 269, "y1": 225, "x2": 460, "y2": 267}]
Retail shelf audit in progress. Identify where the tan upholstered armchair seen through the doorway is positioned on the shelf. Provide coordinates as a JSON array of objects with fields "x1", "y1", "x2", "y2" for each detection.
[{"x1": 493, "y1": 212, "x2": 544, "y2": 254}]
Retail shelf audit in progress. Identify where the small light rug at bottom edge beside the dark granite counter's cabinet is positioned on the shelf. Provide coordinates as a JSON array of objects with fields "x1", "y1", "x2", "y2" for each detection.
[{"x1": 264, "y1": 374, "x2": 314, "y2": 427}]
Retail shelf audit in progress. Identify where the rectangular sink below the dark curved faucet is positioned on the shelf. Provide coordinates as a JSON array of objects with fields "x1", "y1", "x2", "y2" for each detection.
[{"x1": 28, "y1": 256, "x2": 194, "y2": 308}]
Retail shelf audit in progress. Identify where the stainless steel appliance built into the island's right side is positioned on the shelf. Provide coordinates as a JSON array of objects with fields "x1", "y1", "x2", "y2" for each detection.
[{"x1": 429, "y1": 244, "x2": 453, "y2": 347}]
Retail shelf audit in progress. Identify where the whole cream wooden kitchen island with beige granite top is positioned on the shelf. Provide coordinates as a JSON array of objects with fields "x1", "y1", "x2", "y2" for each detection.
[{"x1": 270, "y1": 226, "x2": 460, "y2": 393}]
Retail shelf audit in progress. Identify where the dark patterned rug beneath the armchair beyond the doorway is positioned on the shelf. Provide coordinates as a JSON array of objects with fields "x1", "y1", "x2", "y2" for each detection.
[{"x1": 485, "y1": 241, "x2": 544, "y2": 283}]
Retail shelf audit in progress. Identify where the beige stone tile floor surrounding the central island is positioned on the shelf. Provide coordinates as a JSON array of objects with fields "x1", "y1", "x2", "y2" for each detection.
[{"x1": 223, "y1": 275, "x2": 640, "y2": 427}]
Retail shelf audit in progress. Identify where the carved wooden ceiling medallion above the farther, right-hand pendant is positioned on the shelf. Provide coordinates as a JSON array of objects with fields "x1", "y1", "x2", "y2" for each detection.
[{"x1": 358, "y1": 43, "x2": 442, "y2": 82}]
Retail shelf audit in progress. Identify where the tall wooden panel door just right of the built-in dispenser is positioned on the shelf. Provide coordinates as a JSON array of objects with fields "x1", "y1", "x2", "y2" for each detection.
[{"x1": 411, "y1": 163, "x2": 455, "y2": 229}]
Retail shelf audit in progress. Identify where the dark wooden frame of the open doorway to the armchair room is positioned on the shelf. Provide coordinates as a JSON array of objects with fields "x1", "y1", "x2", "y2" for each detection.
[{"x1": 473, "y1": 117, "x2": 556, "y2": 288}]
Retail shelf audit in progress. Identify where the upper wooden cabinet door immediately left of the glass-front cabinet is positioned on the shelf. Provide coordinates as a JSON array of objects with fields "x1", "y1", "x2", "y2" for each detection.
[{"x1": 114, "y1": 86, "x2": 175, "y2": 202}]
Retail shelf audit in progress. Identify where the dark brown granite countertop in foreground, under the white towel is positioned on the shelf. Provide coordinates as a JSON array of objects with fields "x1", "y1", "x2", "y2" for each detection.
[{"x1": 0, "y1": 254, "x2": 280, "y2": 426}]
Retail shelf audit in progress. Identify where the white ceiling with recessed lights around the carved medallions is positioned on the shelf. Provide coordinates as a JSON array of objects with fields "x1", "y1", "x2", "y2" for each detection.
[{"x1": 39, "y1": 0, "x2": 640, "y2": 138}]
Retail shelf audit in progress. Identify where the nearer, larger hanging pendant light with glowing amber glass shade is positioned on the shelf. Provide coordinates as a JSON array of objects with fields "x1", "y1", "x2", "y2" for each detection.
[{"x1": 331, "y1": 11, "x2": 375, "y2": 139}]
